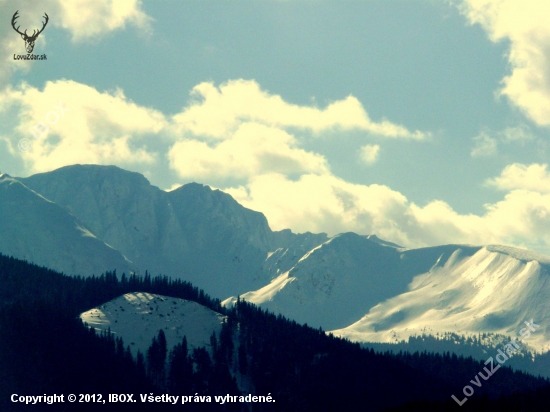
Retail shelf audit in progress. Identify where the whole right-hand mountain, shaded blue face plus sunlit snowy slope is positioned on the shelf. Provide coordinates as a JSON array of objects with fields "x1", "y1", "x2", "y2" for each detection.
[{"x1": 230, "y1": 237, "x2": 550, "y2": 351}]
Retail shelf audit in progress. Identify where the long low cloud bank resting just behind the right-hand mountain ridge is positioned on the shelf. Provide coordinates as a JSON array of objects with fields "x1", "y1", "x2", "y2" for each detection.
[{"x1": 226, "y1": 174, "x2": 488, "y2": 247}]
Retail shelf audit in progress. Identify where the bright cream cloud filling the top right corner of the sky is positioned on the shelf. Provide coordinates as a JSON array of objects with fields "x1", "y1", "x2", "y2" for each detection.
[{"x1": 460, "y1": 0, "x2": 550, "y2": 126}]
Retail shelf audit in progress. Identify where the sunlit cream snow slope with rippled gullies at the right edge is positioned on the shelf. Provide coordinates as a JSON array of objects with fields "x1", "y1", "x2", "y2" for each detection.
[{"x1": 332, "y1": 246, "x2": 550, "y2": 351}]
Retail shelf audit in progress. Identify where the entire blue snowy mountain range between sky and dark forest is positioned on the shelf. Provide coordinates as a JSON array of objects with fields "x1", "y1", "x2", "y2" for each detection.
[{"x1": 0, "y1": 165, "x2": 550, "y2": 351}]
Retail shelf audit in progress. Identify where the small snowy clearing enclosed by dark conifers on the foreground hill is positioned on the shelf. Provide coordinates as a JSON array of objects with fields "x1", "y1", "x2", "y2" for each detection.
[{"x1": 80, "y1": 292, "x2": 225, "y2": 356}]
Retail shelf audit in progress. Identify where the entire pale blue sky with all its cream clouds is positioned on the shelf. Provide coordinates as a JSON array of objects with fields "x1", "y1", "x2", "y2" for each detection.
[{"x1": 0, "y1": 0, "x2": 550, "y2": 254}]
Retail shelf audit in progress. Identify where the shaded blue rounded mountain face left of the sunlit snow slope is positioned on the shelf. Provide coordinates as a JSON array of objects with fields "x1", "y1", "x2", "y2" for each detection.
[{"x1": 223, "y1": 237, "x2": 479, "y2": 330}]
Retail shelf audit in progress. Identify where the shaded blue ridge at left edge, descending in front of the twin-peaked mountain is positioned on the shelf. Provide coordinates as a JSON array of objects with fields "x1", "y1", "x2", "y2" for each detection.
[{"x1": 0, "y1": 174, "x2": 135, "y2": 275}]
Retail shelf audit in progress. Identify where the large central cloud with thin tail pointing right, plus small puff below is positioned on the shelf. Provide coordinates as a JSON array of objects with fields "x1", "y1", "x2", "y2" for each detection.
[{"x1": 168, "y1": 79, "x2": 425, "y2": 185}]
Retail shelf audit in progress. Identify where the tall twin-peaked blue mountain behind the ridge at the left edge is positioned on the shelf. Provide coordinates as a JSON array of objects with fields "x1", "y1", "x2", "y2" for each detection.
[{"x1": 18, "y1": 165, "x2": 327, "y2": 297}]
